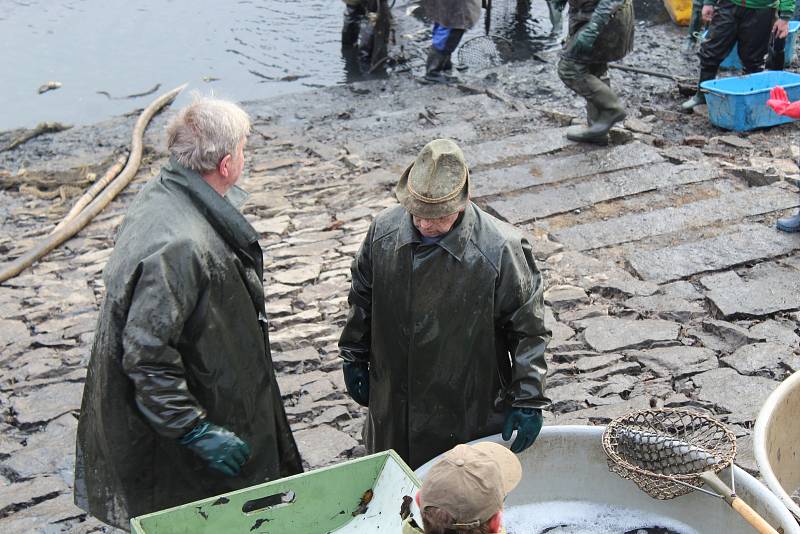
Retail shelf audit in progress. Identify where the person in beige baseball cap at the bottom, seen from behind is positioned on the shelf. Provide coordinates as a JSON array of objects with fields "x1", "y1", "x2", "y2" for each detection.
[{"x1": 403, "y1": 442, "x2": 522, "y2": 534}]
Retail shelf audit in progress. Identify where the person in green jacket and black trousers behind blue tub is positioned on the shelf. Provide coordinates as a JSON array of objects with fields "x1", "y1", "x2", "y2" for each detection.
[{"x1": 681, "y1": 0, "x2": 795, "y2": 113}]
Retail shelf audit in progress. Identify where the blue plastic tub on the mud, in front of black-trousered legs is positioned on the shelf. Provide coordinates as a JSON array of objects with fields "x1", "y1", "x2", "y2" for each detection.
[{"x1": 700, "y1": 70, "x2": 800, "y2": 132}]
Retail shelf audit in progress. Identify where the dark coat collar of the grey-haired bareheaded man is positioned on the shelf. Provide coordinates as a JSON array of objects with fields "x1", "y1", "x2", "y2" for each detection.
[{"x1": 163, "y1": 157, "x2": 258, "y2": 251}]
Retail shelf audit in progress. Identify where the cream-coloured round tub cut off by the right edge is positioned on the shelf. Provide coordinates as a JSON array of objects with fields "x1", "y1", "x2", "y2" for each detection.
[{"x1": 753, "y1": 371, "x2": 800, "y2": 518}]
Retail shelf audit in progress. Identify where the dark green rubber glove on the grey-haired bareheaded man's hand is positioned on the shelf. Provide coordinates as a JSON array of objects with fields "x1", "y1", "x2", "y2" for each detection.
[{"x1": 179, "y1": 421, "x2": 250, "y2": 477}]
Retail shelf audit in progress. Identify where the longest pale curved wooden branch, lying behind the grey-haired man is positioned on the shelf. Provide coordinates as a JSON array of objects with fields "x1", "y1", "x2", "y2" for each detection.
[{"x1": 0, "y1": 84, "x2": 188, "y2": 283}]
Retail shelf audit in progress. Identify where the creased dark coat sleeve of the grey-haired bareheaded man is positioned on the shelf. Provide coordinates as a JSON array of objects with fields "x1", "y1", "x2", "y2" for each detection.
[{"x1": 122, "y1": 242, "x2": 207, "y2": 438}]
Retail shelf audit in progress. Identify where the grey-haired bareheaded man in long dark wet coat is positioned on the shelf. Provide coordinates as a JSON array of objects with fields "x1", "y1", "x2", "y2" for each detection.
[{"x1": 75, "y1": 98, "x2": 302, "y2": 530}]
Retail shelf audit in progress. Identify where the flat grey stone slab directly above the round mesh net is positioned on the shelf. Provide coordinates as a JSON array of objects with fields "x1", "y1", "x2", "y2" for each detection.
[{"x1": 692, "y1": 367, "x2": 779, "y2": 423}]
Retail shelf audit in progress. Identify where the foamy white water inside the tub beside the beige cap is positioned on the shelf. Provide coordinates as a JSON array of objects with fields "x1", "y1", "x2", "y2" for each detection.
[{"x1": 503, "y1": 501, "x2": 699, "y2": 534}]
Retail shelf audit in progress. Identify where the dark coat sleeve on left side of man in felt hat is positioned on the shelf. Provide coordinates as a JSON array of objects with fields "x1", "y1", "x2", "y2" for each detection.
[{"x1": 339, "y1": 222, "x2": 375, "y2": 362}]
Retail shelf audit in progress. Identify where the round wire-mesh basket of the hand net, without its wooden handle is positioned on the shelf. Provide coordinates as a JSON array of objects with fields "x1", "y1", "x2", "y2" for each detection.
[{"x1": 603, "y1": 410, "x2": 736, "y2": 500}]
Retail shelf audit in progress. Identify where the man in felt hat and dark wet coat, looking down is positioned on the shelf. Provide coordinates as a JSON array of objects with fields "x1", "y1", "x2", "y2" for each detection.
[{"x1": 339, "y1": 139, "x2": 550, "y2": 474}]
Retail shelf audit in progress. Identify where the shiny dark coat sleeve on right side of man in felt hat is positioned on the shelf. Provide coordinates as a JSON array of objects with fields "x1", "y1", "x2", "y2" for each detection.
[{"x1": 497, "y1": 237, "x2": 551, "y2": 408}]
